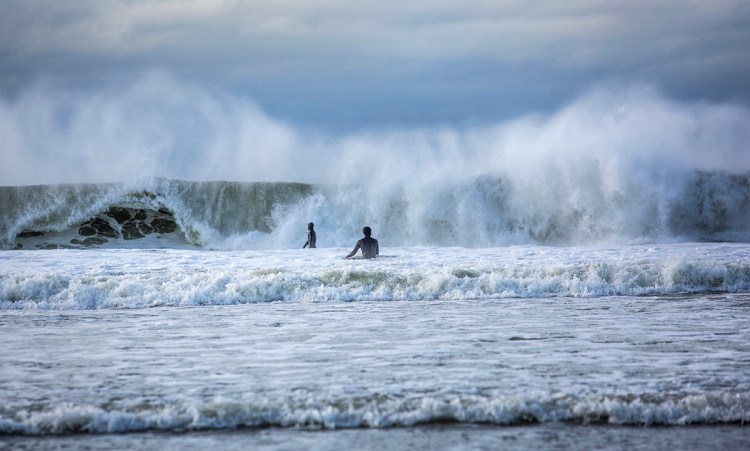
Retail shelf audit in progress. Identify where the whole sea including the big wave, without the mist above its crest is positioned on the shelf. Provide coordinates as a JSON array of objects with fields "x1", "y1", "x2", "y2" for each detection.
[{"x1": 0, "y1": 178, "x2": 750, "y2": 450}]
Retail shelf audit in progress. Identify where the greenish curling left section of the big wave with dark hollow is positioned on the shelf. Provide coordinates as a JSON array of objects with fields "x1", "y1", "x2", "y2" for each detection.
[{"x1": 0, "y1": 178, "x2": 312, "y2": 250}]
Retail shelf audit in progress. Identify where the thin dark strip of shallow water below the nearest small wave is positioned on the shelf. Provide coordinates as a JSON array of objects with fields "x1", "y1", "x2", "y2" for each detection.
[{"x1": 0, "y1": 423, "x2": 750, "y2": 451}]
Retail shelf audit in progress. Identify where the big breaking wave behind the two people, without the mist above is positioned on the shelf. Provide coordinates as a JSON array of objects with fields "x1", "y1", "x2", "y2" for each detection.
[{"x1": 0, "y1": 171, "x2": 750, "y2": 250}]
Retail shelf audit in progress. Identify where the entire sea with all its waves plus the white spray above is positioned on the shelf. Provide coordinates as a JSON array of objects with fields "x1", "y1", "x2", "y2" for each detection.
[{"x1": 0, "y1": 74, "x2": 750, "y2": 449}]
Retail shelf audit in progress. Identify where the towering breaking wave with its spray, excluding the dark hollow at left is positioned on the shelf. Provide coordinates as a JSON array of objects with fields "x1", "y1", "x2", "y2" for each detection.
[{"x1": 0, "y1": 73, "x2": 750, "y2": 249}]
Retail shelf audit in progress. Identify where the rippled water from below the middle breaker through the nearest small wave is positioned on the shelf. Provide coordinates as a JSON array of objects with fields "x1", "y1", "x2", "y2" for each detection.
[{"x1": 0, "y1": 295, "x2": 750, "y2": 435}]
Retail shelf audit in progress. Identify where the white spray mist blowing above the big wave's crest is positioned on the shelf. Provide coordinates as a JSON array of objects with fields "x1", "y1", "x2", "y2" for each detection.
[{"x1": 0, "y1": 72, "x2": 750, "y2": 185}]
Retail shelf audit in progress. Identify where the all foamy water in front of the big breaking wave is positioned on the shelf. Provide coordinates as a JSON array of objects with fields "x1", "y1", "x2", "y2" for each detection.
[{"x1": 0, "y1": 243, "x2": 750, "y2": 449}]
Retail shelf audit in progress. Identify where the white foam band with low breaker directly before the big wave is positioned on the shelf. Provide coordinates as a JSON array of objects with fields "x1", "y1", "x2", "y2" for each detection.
[{"x1": 0, "y1": 243, "x2": 750, "y2": 310}]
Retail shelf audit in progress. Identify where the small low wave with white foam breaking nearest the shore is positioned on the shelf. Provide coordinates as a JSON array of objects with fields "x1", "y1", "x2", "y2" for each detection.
[{"x1": 0, "y1": 392, "x2": 750, "y2": 435}]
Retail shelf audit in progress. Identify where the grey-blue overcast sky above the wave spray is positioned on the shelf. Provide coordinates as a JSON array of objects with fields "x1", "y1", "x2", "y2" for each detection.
[{"x1": 0, "y1": 0, "x2": 750, "y2": 130}]
